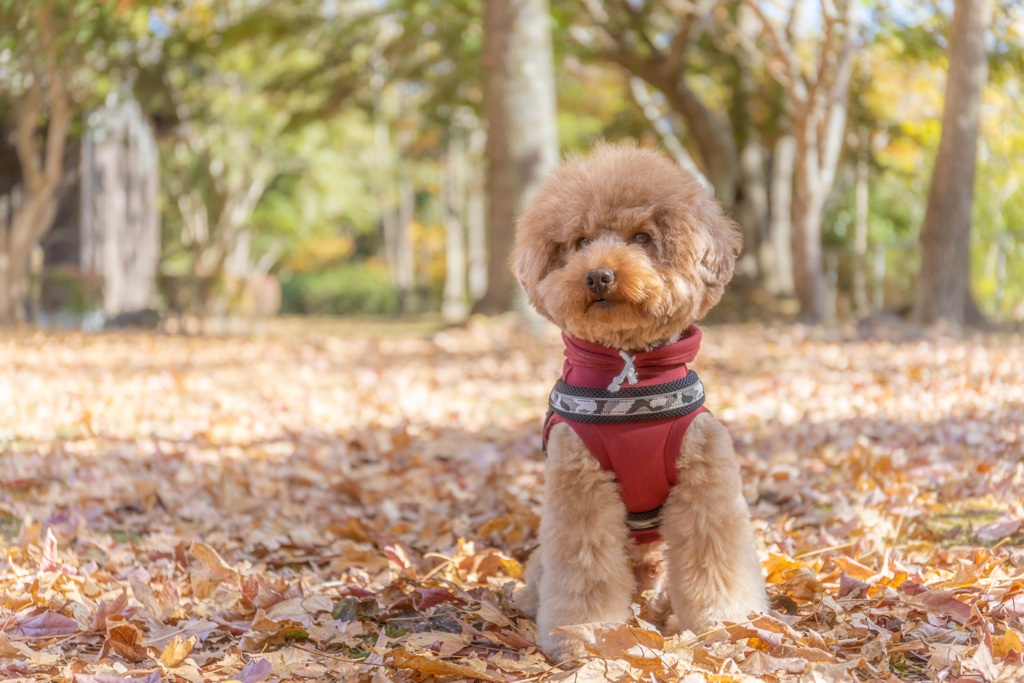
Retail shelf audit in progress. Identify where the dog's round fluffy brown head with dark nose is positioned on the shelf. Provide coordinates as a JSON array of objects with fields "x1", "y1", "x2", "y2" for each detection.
[{"x1": 512, "y1": 144, "x2": 741, "y2": 351}]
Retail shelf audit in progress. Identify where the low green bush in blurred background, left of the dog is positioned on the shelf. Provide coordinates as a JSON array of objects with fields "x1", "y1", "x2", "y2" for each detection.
[{"x1": 282, "y1": 260, "x2": 398, "y2": 315}]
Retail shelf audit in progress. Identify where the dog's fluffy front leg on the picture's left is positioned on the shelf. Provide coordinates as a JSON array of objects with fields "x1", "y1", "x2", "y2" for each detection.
[{"x1": 537, "y1": 424, "x2": 634, "y2": 660}]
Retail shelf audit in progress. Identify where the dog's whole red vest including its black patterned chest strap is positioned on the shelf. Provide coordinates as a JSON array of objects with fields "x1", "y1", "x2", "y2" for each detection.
[{"x1": 544, "y1": 326, "x2": 709, "y2": 543}]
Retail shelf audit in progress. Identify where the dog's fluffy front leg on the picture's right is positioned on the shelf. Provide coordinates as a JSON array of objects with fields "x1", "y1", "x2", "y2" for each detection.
[{"x1": 662, "y1": 414, "x2": 768, "y2": 633}]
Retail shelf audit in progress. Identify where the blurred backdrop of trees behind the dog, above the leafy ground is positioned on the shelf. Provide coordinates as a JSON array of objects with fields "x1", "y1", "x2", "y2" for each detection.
[{"x1": 0, "y1": 0, "x2": 1024, "y2": 331}]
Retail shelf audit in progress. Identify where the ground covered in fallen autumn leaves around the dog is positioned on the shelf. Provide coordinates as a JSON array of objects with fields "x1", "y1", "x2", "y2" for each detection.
[{"x1": 0, "y1": 322, "x2": 1024, "y2": 683}]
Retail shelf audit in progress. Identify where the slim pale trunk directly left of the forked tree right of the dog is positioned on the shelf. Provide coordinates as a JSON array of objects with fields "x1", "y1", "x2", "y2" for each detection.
[{"x1": 760, "y1": 135, "x2": 796, "y2": 297}]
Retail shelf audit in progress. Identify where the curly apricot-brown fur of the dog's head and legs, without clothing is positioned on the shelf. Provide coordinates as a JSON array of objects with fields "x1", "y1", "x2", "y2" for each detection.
[{"x1": 512, "y1": 144, "x2": 768, "y2": 659}]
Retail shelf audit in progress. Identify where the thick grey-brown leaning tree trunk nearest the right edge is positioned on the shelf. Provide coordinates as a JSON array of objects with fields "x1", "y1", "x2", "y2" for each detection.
[{"x1": 913, "y1": 0, "x2": 992, "y2": 325}]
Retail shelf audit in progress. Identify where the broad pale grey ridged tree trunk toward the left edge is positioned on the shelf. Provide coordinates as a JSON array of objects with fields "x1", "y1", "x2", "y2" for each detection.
[{"x1": 81, "y1": 100, "x2": 160, "y2": 316}]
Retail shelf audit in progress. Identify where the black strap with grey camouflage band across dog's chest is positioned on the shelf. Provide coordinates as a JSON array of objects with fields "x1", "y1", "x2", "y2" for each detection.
[{"x1": 548, "y1": 370, "x2": 705, "y2": 424}]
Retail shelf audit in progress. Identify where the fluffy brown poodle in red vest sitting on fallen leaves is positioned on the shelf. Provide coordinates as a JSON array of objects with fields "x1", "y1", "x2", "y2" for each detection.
[{"x1": 511, "y1": 144, "x2": 768, "y2": 660}]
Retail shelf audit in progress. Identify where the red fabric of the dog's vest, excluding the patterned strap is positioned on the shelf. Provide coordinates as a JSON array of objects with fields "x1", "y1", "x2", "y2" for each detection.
[{"x1": 544, "y1": 325, "x2": 709, "y2": 543}]
